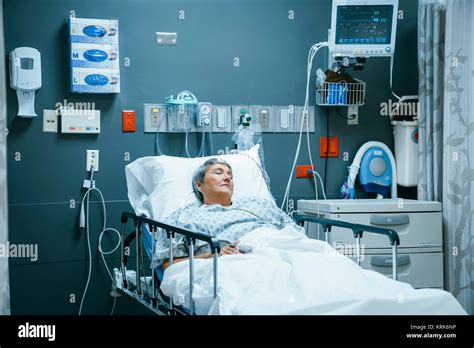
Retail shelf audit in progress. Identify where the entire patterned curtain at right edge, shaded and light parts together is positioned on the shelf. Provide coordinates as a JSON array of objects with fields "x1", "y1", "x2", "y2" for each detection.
[{"x1": 418, "y1": 0, "x2": 474, "y2": 314}]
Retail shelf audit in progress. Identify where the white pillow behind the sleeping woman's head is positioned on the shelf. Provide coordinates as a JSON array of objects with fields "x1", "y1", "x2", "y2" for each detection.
[{"x1": 125, "y1": 144, "x2": 273, "y2": 221}]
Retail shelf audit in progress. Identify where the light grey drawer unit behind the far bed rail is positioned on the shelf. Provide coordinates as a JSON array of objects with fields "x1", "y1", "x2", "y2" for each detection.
[{"x1": 297, "y1": 199, "x2": 443, "y2": 288}]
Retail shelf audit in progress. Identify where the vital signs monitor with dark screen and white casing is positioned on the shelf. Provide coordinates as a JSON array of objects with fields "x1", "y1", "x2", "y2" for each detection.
[{"x1": 329, "y1": 0, "x2": 398, "y2": 57}]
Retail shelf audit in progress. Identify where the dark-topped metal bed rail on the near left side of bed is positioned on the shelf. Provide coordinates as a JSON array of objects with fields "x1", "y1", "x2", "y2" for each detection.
[{"x1": 119, "y1": 212, "x2": 220, "y2": 315}]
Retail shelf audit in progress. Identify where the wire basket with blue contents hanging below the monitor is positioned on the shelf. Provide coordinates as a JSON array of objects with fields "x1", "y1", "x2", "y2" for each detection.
[{"x1": 316, "y1": 79, "x2": 365, "y2": 106}]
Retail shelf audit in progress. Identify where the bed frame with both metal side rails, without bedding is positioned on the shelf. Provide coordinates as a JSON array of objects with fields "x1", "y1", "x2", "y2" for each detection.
[{"x1": 112, "y1": 212, "x2": 400, "y2": 315}]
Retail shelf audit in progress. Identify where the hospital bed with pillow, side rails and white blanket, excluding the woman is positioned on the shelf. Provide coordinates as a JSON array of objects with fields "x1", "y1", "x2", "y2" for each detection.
[{"x1": 112, "y1": 148, "x2": 465, "y2": 315}]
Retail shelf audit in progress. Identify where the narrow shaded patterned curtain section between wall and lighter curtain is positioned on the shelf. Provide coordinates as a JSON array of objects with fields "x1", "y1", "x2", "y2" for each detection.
[{"x1": 418, "y1": 1, "x2": 446, "y2": 202}]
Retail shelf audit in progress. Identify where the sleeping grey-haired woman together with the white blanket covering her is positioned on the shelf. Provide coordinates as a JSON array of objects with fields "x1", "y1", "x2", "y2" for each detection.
[{"x1": 152, "y1": 159, "x2": 466, "y2": 315}]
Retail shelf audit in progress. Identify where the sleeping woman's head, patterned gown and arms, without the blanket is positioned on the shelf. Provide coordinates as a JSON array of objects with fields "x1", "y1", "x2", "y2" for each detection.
[{"x1": 153, "y1": 158, "x2": 304, "y2": 269}]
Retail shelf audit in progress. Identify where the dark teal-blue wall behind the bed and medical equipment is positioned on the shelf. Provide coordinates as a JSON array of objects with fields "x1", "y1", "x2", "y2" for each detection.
[{"x1": 3, "y1": 0, "x2": 418, "y2": 314}]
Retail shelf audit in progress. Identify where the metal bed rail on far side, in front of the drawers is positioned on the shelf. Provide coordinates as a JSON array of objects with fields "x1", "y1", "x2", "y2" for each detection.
[{"x1": 293, "y1": 213, "x2": 400, "y2": 280}]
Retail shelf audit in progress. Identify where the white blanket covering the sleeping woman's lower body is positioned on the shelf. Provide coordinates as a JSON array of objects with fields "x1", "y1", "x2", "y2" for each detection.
[{"x1": 161, "y1": 227, "x2": 466, "y2": 315}]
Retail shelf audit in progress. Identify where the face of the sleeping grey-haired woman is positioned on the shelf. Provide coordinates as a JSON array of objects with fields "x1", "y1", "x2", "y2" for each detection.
[{"x1": 197, "y1": 163, "x2": 234, "y2": 205}]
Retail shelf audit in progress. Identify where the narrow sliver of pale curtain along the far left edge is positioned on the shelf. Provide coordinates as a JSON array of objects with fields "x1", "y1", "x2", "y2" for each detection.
[{"x1": 0, "y1": 0, "x2": 10, "y2": 315}]
